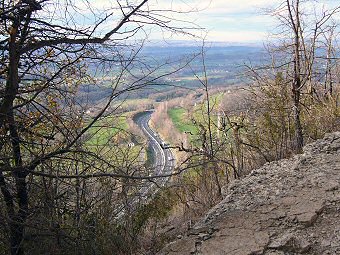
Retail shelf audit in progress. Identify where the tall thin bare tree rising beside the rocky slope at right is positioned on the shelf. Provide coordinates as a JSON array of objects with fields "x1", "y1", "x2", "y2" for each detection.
[{"x1": 262, "y1": 0, "x2": 340, "y2": 152}]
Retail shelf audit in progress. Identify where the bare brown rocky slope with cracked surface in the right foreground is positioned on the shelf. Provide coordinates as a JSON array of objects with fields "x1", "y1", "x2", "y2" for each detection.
[{"x1": 159, "y1": 132, "x2": 340, "y2": 255}]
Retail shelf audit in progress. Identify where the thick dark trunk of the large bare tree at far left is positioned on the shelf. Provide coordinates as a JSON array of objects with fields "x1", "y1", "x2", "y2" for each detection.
[{"x1": 0, "y1": 20, "x2": 28, "y2": 255}]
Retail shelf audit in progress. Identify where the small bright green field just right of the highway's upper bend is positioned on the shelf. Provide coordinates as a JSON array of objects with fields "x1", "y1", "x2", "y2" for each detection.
[{"x1": 168, "y1": 108, "x2": 197, "y2": 134}]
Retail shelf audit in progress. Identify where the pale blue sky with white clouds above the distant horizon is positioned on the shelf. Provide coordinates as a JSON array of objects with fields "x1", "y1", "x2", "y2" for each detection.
[{"x1": 73, "y1": 0, "x2": 340, "y2": 42}]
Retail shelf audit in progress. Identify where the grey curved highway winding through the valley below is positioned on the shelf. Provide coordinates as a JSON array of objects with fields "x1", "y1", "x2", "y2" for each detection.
[{"x1": 134, "y1": 111, "x2": 175, "y2": 199}]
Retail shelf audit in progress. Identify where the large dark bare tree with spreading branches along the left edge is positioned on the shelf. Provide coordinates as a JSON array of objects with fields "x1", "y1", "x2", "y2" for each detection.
[{"x1": 0, "y1": 0, "x2": 199, "y2": 255}]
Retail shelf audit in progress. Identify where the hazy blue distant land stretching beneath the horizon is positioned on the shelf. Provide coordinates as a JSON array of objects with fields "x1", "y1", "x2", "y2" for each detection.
[{"x1": 81, "y1": 41, "x2": 267, "y2": 101}]
